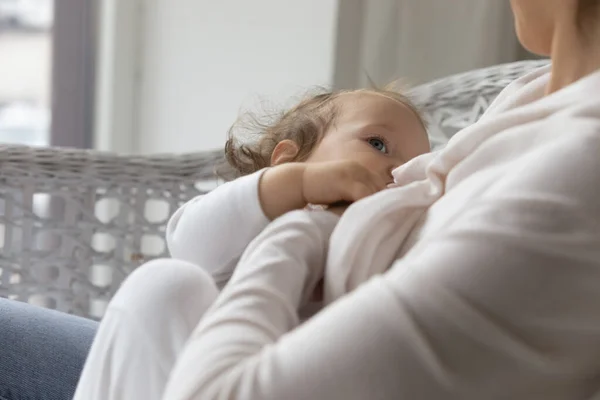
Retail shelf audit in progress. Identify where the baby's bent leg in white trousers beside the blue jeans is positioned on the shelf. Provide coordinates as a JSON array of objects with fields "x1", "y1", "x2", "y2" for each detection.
[{"x1": 75, "y1": 259, "x2": 218, "y2": 400}]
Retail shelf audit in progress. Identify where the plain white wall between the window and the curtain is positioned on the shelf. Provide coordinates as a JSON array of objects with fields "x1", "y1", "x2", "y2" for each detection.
[{"x1": 136, "y1": 0, "x2": 338, "y2": 153}]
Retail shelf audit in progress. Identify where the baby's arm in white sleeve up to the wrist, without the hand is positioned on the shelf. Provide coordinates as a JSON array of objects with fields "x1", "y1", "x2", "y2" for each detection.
[{"x1": 166, "y1": 164, "x2": 306, "y2": 285}]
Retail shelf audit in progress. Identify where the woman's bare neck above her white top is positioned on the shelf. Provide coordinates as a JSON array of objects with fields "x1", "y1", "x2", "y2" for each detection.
[{"x1": 546, "y1": 16, "x2": 600, "y2": 94}]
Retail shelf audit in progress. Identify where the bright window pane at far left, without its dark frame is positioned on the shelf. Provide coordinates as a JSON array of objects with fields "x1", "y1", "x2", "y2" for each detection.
[{"x1": 0, "y1": 0, "x2": 54, "y2": 146}]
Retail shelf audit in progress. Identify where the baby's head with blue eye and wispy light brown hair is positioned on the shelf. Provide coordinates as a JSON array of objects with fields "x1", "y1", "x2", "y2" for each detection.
[{"x1": 225, "y1": 89, "x2": 430, "y2": 182}]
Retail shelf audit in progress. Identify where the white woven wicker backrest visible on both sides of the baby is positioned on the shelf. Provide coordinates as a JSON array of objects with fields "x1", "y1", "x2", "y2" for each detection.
[{"x1": 0, "y1": 61, "x2": 545, "y2": 319}]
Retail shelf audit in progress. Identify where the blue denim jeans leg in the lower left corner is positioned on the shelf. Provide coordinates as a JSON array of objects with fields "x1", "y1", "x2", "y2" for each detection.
[{"x1": 0, "y1": 298, "x2": 98, "y2": 400}]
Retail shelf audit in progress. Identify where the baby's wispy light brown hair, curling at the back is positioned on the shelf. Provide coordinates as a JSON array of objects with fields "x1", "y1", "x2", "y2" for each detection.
[{"x1": 223, "y1": 88, "x2": 425, "y2": 179}]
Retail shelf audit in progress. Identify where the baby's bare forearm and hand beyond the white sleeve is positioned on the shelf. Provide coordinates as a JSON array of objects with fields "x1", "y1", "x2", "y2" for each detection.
[{"x1": 259, "y1": 160, "x2": 386, "y2": 219}]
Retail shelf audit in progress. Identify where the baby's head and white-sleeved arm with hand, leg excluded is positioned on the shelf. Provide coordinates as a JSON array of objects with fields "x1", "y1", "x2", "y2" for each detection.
[{"x1": 162, "y1": 90, "x2": 430, "y2": 310}]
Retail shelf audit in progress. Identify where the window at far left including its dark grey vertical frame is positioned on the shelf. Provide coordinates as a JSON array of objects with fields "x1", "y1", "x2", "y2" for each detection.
[{"x1": 0, "y1": 0, "x2": 97, "y2": 147}]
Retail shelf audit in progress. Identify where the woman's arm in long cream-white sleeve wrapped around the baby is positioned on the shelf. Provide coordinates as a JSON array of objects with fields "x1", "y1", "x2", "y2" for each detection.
[{"x1": 164, "y1": 126, "x2": 600, "y2": 400}]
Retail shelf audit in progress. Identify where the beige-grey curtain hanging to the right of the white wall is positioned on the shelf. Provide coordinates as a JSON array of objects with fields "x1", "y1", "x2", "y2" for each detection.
[{"x1": 333, "y1": 0, "x2": 531, "y2": 88}]
